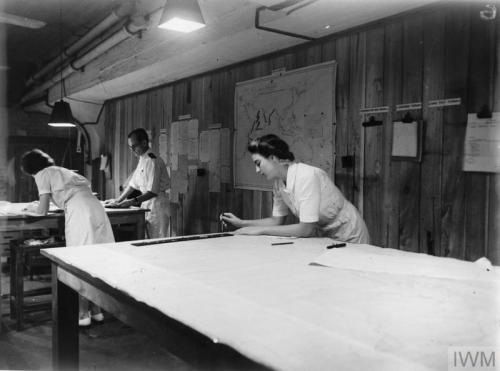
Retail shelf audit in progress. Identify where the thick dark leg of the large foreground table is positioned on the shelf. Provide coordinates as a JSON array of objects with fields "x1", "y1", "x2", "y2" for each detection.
[{"x1": 52, "y1": 264, "x2": 79, "y2": 371}]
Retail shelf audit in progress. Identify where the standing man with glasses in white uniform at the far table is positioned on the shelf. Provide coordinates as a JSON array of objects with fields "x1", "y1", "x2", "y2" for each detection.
[{"x1": 105, "y1": 128, "x2": 170, "y2": 238}]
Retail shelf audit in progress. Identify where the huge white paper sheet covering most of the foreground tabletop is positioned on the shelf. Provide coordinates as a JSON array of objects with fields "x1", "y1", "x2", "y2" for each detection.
[{"x1": 43, "y1": 236, "x2": 500, "y2": 371}]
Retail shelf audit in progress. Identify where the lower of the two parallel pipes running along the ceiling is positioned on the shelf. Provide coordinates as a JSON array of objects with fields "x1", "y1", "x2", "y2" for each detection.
[{"x1": 20, "y1": 16, "x2": 148, "y2": 104}]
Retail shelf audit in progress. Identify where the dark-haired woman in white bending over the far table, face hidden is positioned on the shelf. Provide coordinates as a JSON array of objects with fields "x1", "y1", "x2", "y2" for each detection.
[{"x1": 21, "y1": 149, "x2": 115, "y2": 326}]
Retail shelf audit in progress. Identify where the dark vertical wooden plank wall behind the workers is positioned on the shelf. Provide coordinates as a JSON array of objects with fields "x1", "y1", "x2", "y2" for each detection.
[{"x1": 102, "y1": 3, "x2": 500, "y2": 264}]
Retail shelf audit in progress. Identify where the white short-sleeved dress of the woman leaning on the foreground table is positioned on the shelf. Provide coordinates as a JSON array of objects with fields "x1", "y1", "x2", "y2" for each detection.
[{"x1": 273, "y1": 163, "x2": 370, "y2": 243}]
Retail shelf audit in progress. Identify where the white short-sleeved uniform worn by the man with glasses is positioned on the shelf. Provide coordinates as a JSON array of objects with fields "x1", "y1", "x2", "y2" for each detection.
[{"x1": 129, "y1": 150, "x2": 170, "y2": 238}]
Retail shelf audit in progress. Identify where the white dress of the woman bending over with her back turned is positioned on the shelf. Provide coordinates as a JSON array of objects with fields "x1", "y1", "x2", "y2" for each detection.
[{"x1": 35, "y1": 166, "x2": 115, "y2": 246}]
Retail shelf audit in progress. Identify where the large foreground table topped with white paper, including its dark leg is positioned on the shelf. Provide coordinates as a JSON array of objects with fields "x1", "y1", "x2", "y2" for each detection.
[{"x1": 42, "y1": 236, "x2": 500, "y2": 371}]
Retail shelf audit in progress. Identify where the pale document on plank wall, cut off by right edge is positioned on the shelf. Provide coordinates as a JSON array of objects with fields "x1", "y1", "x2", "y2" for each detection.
[{"x1": 464, "y1": 112, "x2": 500, "y2": 173}]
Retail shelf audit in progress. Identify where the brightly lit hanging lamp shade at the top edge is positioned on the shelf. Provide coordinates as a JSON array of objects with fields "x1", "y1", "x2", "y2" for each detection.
[{"x1": 158, "y1": 0, "x2": 205, "y2": 32}]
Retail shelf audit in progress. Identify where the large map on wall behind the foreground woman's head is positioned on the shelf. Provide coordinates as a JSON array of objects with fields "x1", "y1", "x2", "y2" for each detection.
[{"x1": 234, "y1": 61, "x2": 336, "y2": 190}]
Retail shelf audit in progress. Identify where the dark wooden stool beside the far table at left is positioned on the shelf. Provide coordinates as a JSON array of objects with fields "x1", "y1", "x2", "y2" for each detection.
[{"x1": 10, "y1": 240, "x2": 64, "y2": 331}]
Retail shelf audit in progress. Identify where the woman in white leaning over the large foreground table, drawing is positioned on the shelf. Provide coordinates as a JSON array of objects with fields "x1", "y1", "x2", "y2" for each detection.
[{"x1": 221, "y1": 134, "x2": 370, "y2": 243}]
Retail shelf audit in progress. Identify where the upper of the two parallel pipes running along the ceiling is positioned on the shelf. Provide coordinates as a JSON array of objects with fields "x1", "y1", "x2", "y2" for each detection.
[{"x1": 26, "y1": 1, "x2": 135, "y2": 87}]
